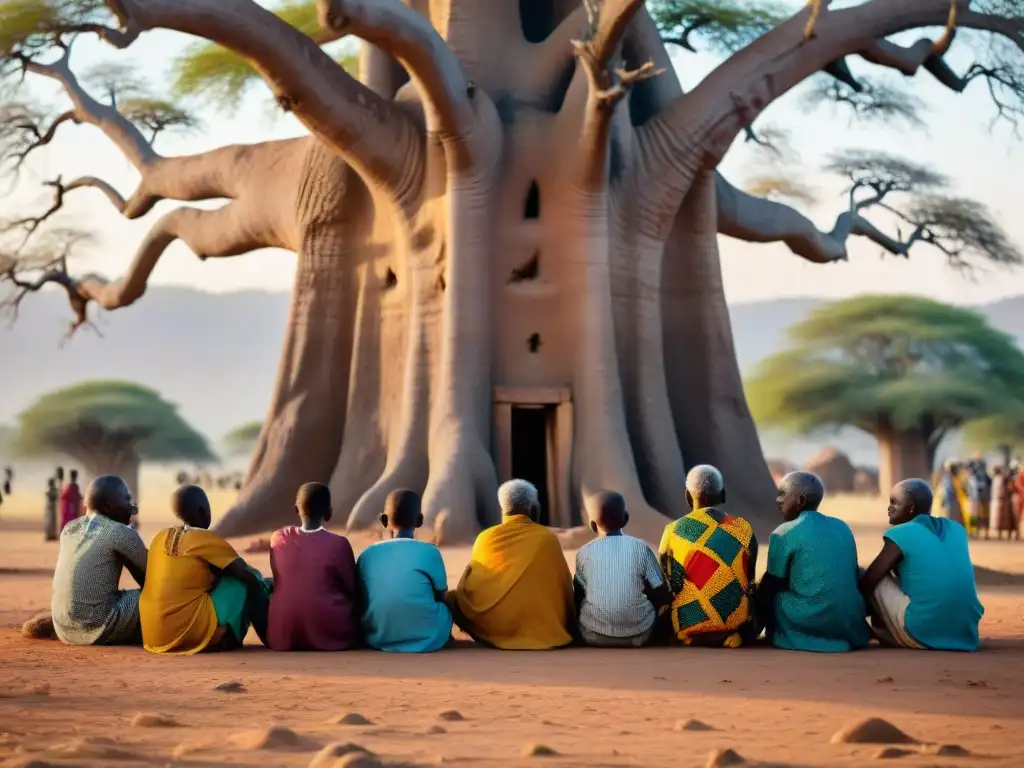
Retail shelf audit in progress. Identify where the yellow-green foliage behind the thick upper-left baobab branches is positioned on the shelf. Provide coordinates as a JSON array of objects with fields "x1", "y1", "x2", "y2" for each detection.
[{"x1": 172, "y1": 0, "x2": 358, "y2": 110}]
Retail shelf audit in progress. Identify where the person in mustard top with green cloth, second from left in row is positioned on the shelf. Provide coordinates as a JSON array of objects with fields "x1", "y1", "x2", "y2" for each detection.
[{"x1": 139, "y1": 485, "x2": 270, "y2": 654}]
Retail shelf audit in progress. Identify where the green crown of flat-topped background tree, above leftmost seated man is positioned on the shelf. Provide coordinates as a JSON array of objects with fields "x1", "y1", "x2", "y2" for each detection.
[{"x1": 15, "y1": 381, "x2": 214, "y2": 462}]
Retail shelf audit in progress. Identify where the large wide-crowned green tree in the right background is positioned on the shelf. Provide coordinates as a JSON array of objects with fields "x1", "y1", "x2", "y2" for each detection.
[{"x1": 746, "y1": 296, "x2": 1024, "y2": 489}]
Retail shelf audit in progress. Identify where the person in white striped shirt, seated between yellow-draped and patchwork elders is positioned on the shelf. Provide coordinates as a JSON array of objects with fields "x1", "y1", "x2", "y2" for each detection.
[{"x1": 572, "y1": 490, "x2": 672, "y2": 648}]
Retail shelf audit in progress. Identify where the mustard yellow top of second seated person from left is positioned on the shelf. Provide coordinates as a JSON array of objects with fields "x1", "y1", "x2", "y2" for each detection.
[{"x1": 138, "y1": 526, "x2": 239, "y2": 654}]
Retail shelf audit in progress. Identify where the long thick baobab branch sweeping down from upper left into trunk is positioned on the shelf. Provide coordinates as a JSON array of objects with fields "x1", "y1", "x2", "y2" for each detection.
[{"x1": 118, "y1": 0, "x2": 422, "y2": 199}]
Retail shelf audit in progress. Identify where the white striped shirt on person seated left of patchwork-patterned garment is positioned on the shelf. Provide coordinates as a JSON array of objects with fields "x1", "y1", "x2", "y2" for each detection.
[{"x1": 575, "y1": 535, "x2": 665, "y2": 638}]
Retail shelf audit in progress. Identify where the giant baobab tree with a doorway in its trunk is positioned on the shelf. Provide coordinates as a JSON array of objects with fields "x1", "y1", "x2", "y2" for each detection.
[{"x1": 0, "y1": 0, "x2": 1024, "y2": 539}]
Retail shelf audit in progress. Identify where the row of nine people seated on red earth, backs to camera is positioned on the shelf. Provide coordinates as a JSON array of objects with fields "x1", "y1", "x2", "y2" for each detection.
[{"x1": 52, "y1": 466, "x2": 983, "y2": 653}]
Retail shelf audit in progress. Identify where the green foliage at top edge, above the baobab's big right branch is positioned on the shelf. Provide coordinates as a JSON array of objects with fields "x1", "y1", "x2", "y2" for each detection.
[{"x1": 647, "y1": 0, "x2": 793, "y2": 53}]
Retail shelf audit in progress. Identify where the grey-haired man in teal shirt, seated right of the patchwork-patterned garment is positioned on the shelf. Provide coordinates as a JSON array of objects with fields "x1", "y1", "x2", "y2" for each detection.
[{"x1": 755, "y1": 472, "x2": 870, "y2": 652}]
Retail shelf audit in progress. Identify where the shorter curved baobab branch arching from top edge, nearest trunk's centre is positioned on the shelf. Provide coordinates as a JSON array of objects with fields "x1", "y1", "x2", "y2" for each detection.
[{"x1": 316, "y1": 0, "x2": 473, "y2": 140}]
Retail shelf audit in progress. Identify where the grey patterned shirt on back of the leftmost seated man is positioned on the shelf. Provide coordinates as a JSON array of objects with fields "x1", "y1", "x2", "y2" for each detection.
[{"x1": 50, "y1": 514, "x2": 145, "y2": 645}]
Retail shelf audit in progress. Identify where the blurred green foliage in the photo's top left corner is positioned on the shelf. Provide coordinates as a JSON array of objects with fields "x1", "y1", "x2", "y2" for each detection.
[{"x1": 0, "y1": 0, "x2": 110, "y2": 56}]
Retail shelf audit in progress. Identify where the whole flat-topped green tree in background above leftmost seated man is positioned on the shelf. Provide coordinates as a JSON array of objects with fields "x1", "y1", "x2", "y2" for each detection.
[{"x1": 14, "y1": 381, "x2": 215, "y2": 495}]
